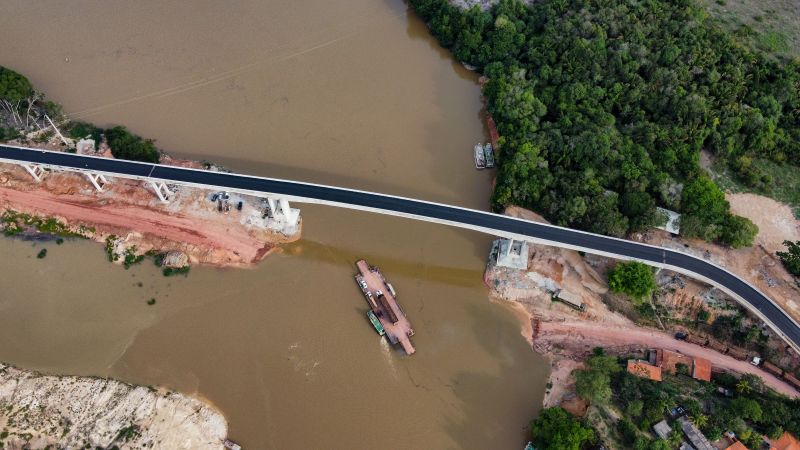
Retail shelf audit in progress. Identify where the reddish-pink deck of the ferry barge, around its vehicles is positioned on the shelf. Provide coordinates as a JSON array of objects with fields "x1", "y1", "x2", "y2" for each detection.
[{"x1": 356, "y1": 259, "x2": 416, "y2": 355}]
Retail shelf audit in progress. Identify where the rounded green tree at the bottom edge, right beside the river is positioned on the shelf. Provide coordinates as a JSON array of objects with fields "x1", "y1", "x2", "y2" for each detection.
[{"x1": 531, "y1": 407, "x2": 594, "y2": 450}]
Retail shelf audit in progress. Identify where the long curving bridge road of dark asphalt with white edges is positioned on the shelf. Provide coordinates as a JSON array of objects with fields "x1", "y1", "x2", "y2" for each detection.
[{"x1": 0, "y1": 145, "x2": 800, "y2": 351}]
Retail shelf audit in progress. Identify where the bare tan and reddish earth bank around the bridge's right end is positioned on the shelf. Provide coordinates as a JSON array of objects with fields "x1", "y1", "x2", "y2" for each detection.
[{"x1": 484, "y1": 207, "x2": 800, "y2": 412}]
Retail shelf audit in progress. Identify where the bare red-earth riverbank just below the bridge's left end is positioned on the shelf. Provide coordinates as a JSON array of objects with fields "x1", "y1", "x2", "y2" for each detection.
[{"x1": 0, "y1": 144, "x2": 302, "y2": 267}]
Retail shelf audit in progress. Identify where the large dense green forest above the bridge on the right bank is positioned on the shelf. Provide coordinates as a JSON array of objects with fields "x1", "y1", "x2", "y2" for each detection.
[{"x1": 410, "y1": 0, "x2": 800, "y2": 247}]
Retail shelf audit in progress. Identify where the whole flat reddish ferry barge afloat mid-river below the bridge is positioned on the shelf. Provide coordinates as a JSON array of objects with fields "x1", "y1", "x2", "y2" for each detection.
[{"x1": 355, "y1": 259, "x2": 416, "y2": 355}]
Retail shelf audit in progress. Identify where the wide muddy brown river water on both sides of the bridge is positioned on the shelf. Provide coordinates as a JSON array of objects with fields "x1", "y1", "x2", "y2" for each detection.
[{"x1": 0, "y1": 0, "x2": 547, "y2": 449}]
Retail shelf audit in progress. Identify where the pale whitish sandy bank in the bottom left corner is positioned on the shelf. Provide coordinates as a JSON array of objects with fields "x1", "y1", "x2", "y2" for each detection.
[{"x1": 0, "y1": 364, "x2": 228, "y2": 449}]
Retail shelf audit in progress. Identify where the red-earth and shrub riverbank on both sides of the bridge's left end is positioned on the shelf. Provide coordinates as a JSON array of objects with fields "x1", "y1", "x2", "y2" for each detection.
[{"x1": 0, "y1": 66, "x2": 301, "y2": 276}]
